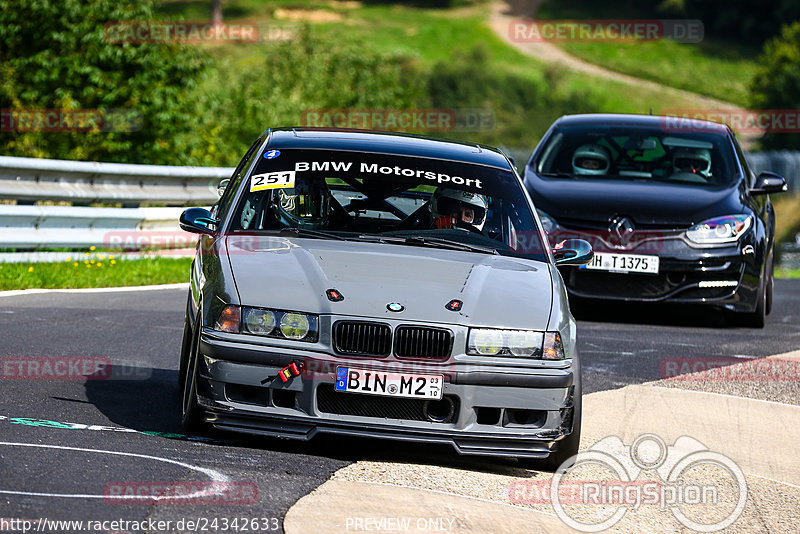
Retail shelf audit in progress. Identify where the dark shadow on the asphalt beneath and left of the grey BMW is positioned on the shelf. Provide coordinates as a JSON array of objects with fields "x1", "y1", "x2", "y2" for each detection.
[{"x1": 84, "y1": 365, "x2": 536, "y2": 475}]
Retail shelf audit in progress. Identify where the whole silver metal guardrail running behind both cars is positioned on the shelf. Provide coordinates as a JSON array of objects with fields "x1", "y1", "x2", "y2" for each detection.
[{"x1": 0, "y1": 152, "x2": 800, "y2": 258}]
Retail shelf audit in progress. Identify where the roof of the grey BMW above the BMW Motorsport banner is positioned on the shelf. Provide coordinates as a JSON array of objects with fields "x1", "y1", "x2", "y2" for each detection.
[{"x1": 267, "y1": 128, "x2": 511, "y2": 169}]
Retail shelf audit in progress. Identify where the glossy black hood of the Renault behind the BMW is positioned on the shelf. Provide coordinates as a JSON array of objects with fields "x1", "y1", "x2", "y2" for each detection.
[{"x1": 526, "y1": 174, "x2": 742, "y2": 228}]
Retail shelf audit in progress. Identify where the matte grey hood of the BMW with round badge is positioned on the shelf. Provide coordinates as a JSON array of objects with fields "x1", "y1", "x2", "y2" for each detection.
[{"x1": 222, "y1": 237, "x2": 552, "y2": 329}]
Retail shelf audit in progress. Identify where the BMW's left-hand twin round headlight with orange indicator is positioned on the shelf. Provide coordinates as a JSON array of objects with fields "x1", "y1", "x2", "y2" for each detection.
[{"x1": 220, "y1": 306, "x2": 319, "y2": 343}]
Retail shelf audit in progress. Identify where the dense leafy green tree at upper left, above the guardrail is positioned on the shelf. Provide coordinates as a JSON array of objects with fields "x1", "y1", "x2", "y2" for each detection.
[{"x1": 0, "y1": 0, "x2": 204, "y2": 164}]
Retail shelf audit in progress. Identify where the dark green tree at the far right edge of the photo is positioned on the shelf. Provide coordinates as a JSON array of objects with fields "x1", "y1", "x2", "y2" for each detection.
[{"x1": 750, "y1": 22, "x2": 800, "y2": 149}]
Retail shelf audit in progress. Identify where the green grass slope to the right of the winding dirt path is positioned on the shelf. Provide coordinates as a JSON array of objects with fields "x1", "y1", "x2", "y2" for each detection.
[{"x1": 539, "y1": 1, "x2": 760, "y2": 109}]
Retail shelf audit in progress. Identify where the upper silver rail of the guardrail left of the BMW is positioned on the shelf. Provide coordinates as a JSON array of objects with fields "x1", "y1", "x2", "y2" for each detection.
[{"x1": 0, "y1": 156, "x2": 233, "y2": 206}]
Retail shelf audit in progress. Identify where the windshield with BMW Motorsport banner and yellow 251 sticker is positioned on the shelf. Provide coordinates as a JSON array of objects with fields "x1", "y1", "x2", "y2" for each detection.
[{"x1": 228, "y1": 149, "x2": 547, "y2": 261}]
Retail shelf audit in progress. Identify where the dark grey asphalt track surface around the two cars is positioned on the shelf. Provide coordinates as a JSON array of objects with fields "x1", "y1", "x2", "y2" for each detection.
[{"x1": 0, "y1": 281, "x2": 800, "y2": 531}]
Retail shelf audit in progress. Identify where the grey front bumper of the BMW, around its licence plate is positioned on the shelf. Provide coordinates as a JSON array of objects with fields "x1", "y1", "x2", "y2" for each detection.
[{"x1": 197, "y1": 328, "x2": 580, "y2": 458}]
